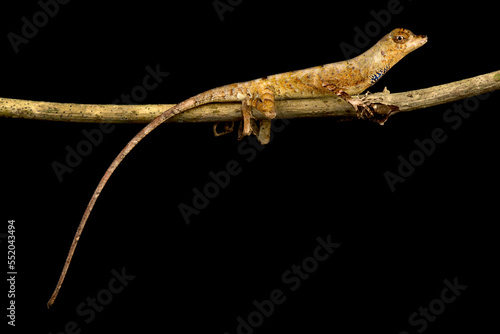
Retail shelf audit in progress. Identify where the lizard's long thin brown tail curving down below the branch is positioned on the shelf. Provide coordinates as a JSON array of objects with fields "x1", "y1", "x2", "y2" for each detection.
[{"x1": 47, "y1": 94, "x2": 202, "y2": 308}]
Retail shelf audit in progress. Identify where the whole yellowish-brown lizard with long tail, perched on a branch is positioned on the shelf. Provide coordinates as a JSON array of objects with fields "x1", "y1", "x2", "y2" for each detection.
[{"x1": 47, "y1": 28, "x2": 427, "y2": 308}]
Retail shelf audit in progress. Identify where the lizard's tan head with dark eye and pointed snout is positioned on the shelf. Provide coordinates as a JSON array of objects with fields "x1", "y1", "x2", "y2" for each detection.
[{"x1": 380, "y1": 28, "x2": 427, "y2": 59}]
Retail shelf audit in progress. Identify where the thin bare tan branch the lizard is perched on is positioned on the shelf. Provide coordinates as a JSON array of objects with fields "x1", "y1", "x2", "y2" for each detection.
[{"x1": 0, "y1": 71, "x2": 500, "y2": 123}]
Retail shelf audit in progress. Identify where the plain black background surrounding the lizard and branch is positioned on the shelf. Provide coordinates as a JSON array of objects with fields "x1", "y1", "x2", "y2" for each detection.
[{"x1": 0, "y1": 0, "x2": 499, "y2": 334}]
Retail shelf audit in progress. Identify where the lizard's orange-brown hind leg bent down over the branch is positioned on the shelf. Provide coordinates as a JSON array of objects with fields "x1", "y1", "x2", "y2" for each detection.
[{"x1": 239, "y1": 87, "x2": 276, "y2": 145}]
